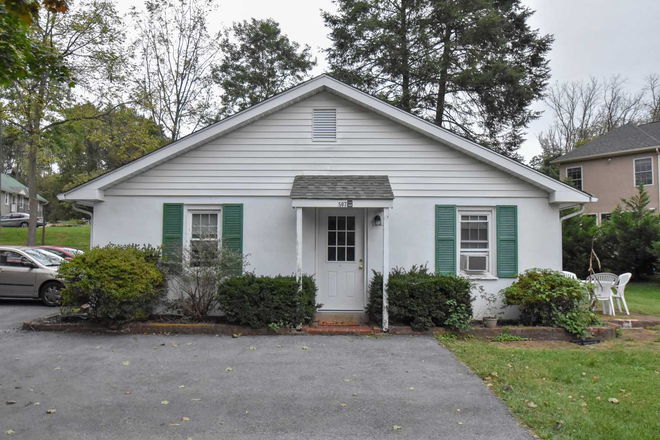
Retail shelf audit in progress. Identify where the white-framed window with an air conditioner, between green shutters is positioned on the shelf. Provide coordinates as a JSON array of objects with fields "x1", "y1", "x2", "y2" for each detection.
[{"x1": 458, "y1": 211, "x2": 494, "y2": 275}]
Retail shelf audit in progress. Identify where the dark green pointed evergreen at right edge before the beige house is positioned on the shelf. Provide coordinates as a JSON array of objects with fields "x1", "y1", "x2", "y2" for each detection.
[{"x1": 599, "y1": 186, "x2": 660, "y2": 280}]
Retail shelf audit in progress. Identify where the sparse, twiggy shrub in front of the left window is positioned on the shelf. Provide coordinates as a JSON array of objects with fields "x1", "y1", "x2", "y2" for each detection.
[{"x1": 160, "y1": 241, "x2": 247, "y2": 321}]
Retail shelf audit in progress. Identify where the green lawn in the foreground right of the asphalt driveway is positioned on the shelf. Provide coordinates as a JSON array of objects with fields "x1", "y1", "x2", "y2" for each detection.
[{"x1": 441, "y1": 333, "x2": 660, "y2": 439}]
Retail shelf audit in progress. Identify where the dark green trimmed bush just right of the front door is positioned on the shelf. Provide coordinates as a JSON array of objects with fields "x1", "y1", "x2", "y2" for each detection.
[{"x1": 367, "y1": 266, "x2": 475, "y2": 331}]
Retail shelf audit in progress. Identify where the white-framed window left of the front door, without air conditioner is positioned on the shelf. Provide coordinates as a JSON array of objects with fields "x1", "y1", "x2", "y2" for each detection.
[{"x1": 188, "y1": 211, "x2": 221, "y2": 266}]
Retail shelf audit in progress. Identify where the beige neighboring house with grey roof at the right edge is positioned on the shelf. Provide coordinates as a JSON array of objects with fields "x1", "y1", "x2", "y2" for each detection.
[{"x1": 553, "y1": 122, "x2": 660, "y2": 224}]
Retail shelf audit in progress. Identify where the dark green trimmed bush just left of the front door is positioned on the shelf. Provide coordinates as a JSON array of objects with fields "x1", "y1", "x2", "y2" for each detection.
[{"x1": 218, "y1": 273, "x2": 321, "y2": 328}]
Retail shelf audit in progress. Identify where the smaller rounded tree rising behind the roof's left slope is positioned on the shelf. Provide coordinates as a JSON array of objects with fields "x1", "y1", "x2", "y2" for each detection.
[{"x1": 213, "y1": 18, "x2": 316, "y2": 115}]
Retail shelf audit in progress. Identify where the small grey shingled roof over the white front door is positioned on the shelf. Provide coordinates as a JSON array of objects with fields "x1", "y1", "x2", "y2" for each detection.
[{"x1": 291, "y1": 176, "x2": 394, "y2": 200}]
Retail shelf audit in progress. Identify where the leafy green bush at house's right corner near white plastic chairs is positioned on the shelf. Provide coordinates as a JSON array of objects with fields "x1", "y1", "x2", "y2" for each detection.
[{"x1": 503, "y1": 269, "x2": 600, "y2": 337}]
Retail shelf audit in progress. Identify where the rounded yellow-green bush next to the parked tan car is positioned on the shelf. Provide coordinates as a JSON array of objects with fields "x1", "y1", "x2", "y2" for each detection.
[{"x1": 58, "y1": 245, "x2": 166, "y2": 321}]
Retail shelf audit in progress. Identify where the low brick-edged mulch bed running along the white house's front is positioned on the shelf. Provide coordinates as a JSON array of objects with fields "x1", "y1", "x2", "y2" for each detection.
[{"x1": 23, "y1": 315, "x2": 618, "y2": 341}]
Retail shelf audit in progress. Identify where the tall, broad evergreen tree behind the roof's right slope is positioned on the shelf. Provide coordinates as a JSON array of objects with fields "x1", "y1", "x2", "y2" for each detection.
[{"x1": 322, "y1": 0, "x2": 553, "y2": 159}]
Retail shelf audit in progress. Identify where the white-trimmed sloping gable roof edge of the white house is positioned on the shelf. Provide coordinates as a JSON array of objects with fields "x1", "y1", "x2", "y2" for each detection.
[{"x1": 57, "y1": 74, "x2": 597, "y2": 203}]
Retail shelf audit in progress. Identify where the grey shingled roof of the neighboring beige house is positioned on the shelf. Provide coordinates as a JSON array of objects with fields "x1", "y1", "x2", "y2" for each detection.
[{"x1": 553, "y1": 122, "x2": 660, "y2": 163}]
